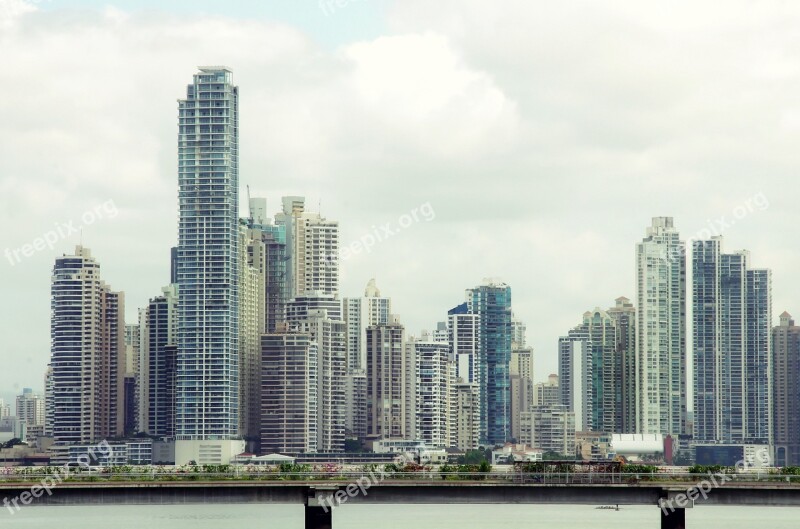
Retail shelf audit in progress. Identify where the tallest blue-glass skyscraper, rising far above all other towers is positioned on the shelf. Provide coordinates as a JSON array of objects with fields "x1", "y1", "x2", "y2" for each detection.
[{"x1": 175, "y1": 66, "x2": 240, "y2": 464}]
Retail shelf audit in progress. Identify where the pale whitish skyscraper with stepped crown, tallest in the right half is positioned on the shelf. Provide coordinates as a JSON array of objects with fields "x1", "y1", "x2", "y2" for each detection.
[{"x1": 636, "y1": 217, "x2": 687, "y2": 436}]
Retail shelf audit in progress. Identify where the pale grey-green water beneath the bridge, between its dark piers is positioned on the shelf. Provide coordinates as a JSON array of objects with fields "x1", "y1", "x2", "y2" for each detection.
[{"x1": 0, "y1": 504, "x2": 800, "y2": 529}]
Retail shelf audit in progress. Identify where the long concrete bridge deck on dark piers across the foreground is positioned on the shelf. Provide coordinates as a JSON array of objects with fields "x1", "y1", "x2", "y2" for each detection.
[{"x1": 0, "y1": 473, "x2": 800, "y2": 529}]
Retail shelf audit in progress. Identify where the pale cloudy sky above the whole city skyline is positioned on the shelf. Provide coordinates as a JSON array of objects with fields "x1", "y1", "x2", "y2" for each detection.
[{"x1": 0, "y1": 0, "x2": 800, "y2": 398}]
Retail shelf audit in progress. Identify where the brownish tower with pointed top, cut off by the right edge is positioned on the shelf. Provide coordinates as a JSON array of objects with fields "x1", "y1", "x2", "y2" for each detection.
[{"x1": 772, "y1": 312, "x2": 800, "y2": 466}]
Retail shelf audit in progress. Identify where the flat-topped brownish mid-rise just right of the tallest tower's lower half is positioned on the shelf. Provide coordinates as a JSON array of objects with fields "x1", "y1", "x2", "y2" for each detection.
[{"x1": 260, "y1": 333, "x2": 319, "y2": 454}]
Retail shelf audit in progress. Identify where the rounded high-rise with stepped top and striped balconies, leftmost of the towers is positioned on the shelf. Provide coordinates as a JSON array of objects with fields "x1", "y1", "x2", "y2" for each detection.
[{"x1": 48, "y1": 246, "x2": 126, "y2": 446}]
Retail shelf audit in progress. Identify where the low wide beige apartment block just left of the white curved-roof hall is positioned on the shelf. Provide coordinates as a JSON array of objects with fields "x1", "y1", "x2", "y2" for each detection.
[{"x1": 520, "y1": 405, "x2": 575, "y2": 457}]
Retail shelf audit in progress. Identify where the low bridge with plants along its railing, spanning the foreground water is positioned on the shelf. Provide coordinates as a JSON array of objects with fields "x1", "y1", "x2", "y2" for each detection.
[{"x1": 0, "y1": 470, "x2": 800, "y2": 529}]
